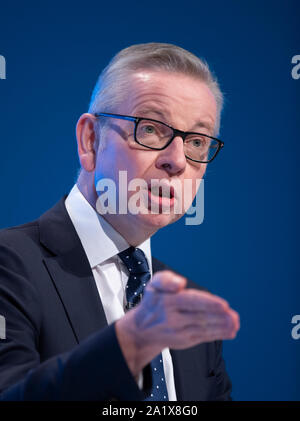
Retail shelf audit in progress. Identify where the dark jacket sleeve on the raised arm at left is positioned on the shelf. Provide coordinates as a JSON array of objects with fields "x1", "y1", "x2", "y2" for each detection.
[{"x1": 0, "y1": 241, "x2": 144, "y2": 401}]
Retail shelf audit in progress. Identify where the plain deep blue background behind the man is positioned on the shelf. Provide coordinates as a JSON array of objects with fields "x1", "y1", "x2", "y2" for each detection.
[{"x1": 0, "y1": 0, "x2": 300, "y2": 400}]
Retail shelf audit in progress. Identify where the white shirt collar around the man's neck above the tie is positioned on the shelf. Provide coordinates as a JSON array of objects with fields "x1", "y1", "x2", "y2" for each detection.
[{"x1": 65, "y1": 184, "x2": 152, "y2": 273}]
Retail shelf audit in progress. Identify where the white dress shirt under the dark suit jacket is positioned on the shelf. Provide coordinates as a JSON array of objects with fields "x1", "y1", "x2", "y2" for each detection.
[{"x1": 65, "y1": 184, "x2": 177, "y2": 401}]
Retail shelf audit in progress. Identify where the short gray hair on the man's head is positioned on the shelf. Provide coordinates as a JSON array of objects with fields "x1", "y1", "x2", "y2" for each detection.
[{"x1": 88, "y1": 42, "x2": 223, "y2": 136}]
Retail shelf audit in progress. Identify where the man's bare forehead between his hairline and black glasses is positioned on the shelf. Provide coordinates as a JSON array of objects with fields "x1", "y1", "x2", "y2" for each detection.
[{"x1": 118, "y1": 70, "x2": 217, "y2": 130}]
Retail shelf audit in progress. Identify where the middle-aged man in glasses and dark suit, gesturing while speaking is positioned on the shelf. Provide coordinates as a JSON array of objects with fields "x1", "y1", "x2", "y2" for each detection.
[{"x1": 0, "y1": 43, "x2": 239, "y2": 401}]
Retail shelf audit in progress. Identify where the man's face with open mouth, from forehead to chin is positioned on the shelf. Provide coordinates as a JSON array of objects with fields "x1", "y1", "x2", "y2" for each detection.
[{"x1": 95, "y1": 71, "x2": 217, "y2": 234}]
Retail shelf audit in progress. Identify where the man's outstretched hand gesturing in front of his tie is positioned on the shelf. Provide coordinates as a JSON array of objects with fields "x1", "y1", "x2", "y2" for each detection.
[{"x1": 115, "y1": 271, "x2": 240, "y2": 376}]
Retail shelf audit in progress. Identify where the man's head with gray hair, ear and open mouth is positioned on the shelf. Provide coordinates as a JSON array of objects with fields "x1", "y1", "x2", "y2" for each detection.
[{"x1": 77, "y1": 43, "x2": 223, "y2": 244}]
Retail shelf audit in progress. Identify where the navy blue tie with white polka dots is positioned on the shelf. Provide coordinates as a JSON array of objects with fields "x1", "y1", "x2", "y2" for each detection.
[{"x1": 119, "y1": 247, "x2": 168, "y2": 401}]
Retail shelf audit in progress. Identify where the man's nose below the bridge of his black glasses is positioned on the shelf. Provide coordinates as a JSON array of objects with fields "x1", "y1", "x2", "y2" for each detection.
[{"x1": 156, "y1": 136, "x2": 186, "y2": 175}]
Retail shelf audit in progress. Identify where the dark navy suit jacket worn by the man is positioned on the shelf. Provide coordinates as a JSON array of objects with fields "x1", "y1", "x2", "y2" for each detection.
[{"x1": 0, "y1": 197, "x2": 231, "y2": 401}]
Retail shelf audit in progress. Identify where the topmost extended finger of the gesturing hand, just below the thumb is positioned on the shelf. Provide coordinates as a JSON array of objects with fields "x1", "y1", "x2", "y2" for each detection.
[{"x1": 174, "y1": 289, "x2": 229, "y2": 312}]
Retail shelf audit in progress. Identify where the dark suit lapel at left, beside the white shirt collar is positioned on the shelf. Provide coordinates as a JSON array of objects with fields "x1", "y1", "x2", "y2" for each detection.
[{"x1": 39, "y1": 196, "x2": 107, "y2": 342}]
